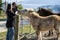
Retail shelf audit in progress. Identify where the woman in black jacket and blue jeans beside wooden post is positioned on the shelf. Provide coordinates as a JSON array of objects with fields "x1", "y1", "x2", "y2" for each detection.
[{"x1": 6, "y1": 4, "x2": 15, "y2": 40}]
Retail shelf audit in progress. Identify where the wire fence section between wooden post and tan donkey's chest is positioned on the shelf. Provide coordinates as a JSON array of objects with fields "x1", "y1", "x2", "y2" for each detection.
[{"x1": 19, "y1": 16, "x2": 35, "y2": 34}]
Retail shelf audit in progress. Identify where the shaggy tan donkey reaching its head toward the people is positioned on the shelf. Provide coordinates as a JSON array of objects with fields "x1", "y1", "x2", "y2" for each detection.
[{"x1": 18, "y1": 9, "x2": 60, "y2": 40}]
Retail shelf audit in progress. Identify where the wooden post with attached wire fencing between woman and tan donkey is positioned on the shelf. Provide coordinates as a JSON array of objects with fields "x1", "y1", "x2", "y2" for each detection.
[{"x1": 14, "y1": 15, "x2": 34, "y2": 40}]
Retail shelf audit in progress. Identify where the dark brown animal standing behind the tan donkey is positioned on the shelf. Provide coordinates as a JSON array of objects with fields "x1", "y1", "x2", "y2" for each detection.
[{"x1": 37, "y1": 8, "x2": 60, "y2": 36}]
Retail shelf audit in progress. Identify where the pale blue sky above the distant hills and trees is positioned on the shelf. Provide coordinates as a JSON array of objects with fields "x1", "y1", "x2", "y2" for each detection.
[{"x1": 3, "y1": 0, "x2": 60, "y2": 8}]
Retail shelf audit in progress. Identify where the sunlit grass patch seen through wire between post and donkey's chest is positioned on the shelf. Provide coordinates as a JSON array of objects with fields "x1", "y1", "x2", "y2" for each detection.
[{"x1": 19, "y1": 25, "x2": 35, "y2": 34}]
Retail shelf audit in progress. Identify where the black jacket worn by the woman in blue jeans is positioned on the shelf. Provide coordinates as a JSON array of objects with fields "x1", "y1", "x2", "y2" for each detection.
[{"x1": 6, "y1": 11, "x2": 15, "y2": 28}]
